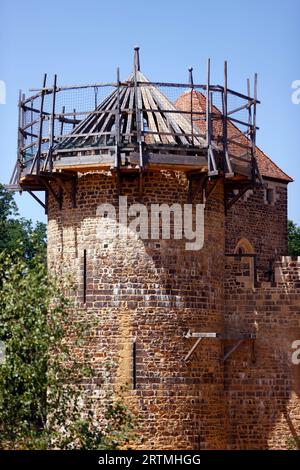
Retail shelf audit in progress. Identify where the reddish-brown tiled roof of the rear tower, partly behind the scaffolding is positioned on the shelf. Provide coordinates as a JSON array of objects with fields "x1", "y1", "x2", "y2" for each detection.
[{"x1": 175, "y1": 91, "x2": 293, "y2": 183}]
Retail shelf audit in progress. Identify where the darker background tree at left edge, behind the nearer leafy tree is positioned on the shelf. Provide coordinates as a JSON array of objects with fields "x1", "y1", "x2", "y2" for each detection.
[{"x1": 0, "y1": 184, "x2": 46, "y2": 262}]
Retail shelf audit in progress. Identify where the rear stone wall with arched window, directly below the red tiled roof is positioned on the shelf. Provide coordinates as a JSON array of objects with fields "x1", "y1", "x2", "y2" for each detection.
[{"x1": 225, "y1": 180, "x2": 287, "y2": 279}]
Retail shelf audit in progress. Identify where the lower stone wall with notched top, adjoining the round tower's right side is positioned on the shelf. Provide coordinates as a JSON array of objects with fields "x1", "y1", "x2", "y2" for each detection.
[{"x1": 224, "y1": 257, "x2": 300, "y2": 449}]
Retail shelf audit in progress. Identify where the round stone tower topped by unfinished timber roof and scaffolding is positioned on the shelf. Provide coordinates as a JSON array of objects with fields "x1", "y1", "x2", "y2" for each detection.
[{"x1": 12, "y1": 48, "x2": 258, "y2": 449}]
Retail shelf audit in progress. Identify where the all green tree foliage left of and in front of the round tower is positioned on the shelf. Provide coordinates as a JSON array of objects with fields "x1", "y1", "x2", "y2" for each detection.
[{"x1": 0, "y1": 186, "x2": 133, "y2": 449}]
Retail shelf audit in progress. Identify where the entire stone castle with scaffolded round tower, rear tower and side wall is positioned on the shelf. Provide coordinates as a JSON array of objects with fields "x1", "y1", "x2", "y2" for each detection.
[{"x1": 11, "y1": 48, "x2": 300, "y2": 449}]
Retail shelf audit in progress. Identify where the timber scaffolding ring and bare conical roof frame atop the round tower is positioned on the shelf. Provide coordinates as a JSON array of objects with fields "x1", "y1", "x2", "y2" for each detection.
[{"x1": 6, "y1": 47, "x2": 262, "y2": 210}]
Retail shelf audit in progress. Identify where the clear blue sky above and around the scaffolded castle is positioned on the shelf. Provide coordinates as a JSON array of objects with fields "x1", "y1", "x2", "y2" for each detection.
[{"x1": 0, "y1": 0, "x2": 300, "y2": 224}]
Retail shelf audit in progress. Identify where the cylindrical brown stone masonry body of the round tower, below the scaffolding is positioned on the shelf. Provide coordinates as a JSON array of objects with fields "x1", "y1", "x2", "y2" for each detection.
[{"x1": 48, "y1": 172, "x2": 226, "y2": 449}]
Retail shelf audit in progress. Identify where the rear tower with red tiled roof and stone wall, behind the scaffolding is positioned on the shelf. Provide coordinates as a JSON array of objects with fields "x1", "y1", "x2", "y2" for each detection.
[{"x1": 176, "y1": 91, "x2": 287, "y2": 279}]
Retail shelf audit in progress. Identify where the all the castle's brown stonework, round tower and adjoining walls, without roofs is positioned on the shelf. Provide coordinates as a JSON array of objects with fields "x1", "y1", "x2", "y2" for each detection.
[{"x1": 48, "y1": 172, "x2": 300, "y2": 449}]
